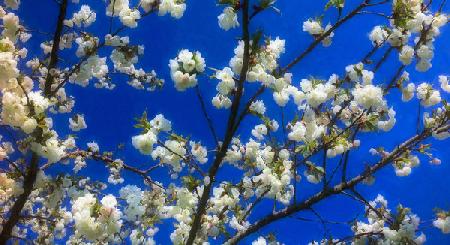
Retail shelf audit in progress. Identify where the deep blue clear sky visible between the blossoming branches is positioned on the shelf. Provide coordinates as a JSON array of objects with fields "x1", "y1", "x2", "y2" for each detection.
[{"x1": 13, "y1": 0, "x2": 450, "y2": 244}]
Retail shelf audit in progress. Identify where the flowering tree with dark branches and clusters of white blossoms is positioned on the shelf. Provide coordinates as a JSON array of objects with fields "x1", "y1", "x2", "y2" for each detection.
[{"x1": 0, "y1": 0, "x2": 450, "y2": 244}]
